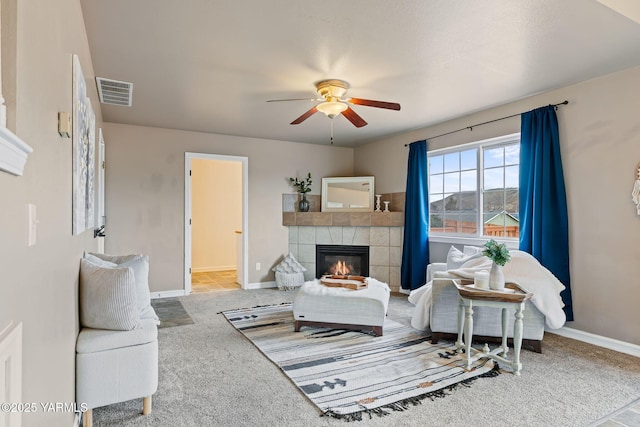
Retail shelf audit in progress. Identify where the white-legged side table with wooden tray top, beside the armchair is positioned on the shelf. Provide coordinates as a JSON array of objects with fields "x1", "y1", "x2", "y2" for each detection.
[{"x1": 453, "y1": 280, "x2": 533, "y2": 375}]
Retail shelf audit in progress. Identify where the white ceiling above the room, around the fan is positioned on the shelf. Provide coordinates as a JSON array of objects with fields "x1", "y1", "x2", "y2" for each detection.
[{"x1": 81, "y1": 0, "x2": 640, "y2": 146}]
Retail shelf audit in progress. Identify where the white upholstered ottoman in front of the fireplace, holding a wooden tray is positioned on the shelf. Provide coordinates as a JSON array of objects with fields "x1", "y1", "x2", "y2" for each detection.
[{"x1": 293, "y1": 277, "x2": 391, "y2": 336}]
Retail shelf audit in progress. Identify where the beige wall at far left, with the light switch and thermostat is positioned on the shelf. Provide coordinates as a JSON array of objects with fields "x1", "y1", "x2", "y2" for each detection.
[{"x1": 0, "y1": 0, "x2": 102, "y2": 427}]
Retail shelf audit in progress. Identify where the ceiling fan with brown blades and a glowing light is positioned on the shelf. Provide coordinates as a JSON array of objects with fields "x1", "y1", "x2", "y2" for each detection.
[{"x1": 267, "y1": 79, "x2": 400, "y2": 128}]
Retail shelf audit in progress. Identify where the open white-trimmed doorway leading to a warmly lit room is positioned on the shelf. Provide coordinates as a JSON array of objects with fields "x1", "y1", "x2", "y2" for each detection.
[{"x1": 184, "y1": 152, "x2": 248, "y2": 295}]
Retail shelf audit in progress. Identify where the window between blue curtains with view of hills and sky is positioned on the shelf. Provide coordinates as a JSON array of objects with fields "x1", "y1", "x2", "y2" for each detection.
[{"x1": 427, "y1": 134, "x2": 520, "y2": 238}]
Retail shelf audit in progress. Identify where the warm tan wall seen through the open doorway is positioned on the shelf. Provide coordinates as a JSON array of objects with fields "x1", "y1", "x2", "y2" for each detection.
[{"x1": 191, "y1": 159, "x2": 242, "y2": 272}]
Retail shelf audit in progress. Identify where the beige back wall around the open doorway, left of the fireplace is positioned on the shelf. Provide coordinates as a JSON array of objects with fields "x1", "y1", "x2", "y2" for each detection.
[{"x1": 104, "y1": 123, "x2": 353, "y2": 292}]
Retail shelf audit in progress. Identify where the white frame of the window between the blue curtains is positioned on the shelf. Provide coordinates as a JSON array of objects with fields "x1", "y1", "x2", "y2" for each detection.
[{"x1": 427, "y1": 132, "x2": 520, "y2": 249}]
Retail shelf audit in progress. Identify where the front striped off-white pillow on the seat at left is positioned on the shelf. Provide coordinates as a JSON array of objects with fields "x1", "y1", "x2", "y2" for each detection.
[{"x1": 80, "y1": 259, "x2": 140, "y2": 331}]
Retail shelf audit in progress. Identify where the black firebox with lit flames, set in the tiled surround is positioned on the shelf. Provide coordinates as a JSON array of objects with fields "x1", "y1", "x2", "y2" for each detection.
[{"x1": 316, "y1": 245, "x2": 369, "y2": 278}]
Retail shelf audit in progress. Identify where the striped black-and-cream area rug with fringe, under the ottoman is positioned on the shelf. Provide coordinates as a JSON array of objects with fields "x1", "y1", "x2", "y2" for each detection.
[{"x1": 222, "y1": 303, "x2": 498, "y2": 421}]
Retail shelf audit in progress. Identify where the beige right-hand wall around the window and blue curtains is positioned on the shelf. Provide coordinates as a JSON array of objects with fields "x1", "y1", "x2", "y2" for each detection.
[{"x1": 355, "y1": 68, "x2": 640, "y2": 344}]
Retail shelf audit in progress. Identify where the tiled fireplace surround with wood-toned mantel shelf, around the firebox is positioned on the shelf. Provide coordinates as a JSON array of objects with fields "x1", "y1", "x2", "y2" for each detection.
[{"x1": 282, "y1": 193, "x2": 404, "y2": 292}]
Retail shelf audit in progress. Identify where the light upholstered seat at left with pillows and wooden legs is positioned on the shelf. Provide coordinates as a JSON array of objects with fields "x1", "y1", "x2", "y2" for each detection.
[{"x1": 76, "y1": 254, "x2": 159, "y2": 427}]
